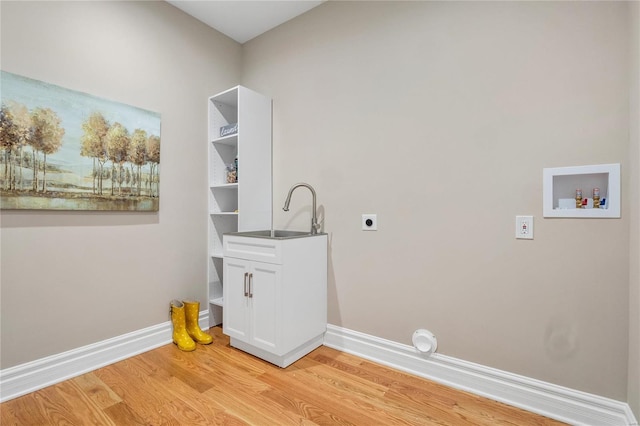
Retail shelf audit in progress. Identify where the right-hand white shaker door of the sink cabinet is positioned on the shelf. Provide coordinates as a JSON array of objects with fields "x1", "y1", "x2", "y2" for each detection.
[{"x1": 249, "y1": 262, "x2": 282, "y2": 354}]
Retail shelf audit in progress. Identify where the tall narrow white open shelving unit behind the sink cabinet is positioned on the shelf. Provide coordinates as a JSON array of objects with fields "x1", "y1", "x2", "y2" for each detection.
[{"x1": 207, "y1": 86, "x2": 272, "y2": 326}]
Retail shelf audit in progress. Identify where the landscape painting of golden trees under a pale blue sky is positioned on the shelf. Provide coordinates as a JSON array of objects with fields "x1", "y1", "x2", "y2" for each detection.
[{"x1": 0, "y1": 71, "x2": 160, "y2": 211}]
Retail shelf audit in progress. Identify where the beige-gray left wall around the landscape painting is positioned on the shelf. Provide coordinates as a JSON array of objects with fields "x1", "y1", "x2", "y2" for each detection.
[{"x1": 0, "y1": 1, "x2": 241, "y2": 368}]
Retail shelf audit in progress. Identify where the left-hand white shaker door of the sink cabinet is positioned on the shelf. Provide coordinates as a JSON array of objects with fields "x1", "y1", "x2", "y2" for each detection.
[{"x1": 222, "y1": 258, "x2": 250, "y2": 343}]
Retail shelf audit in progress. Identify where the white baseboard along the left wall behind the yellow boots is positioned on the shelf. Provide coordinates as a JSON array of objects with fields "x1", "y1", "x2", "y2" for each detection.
[{"x1": 0, "y1": 309, "x2": 209, "y2": 402}]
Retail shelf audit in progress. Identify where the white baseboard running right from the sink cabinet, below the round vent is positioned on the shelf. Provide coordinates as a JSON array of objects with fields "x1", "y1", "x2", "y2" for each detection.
[{"x1": 324, "y1": 325, "x2": 638, "y2": 426}]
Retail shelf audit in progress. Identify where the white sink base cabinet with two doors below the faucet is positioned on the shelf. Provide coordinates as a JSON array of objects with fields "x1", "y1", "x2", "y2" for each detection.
[{"x1": 222, "y1": 234, "x2": 327, "y2": 367}]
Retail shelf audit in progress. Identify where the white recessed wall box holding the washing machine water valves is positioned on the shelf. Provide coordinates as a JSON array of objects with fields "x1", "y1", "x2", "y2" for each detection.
[{"x1": 542, "y1": 164, "x2": 620, "y2": 218}]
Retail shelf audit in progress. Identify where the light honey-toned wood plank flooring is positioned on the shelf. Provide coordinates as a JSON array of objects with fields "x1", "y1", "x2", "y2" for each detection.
[{"x1": 0, "y1": 327, "x2": 562, "y2": 426}]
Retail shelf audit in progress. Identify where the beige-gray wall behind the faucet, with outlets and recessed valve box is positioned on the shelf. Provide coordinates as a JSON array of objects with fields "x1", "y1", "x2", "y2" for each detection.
[{"x1": 242, "y1": 2, "x2": 637, "y2": 400}]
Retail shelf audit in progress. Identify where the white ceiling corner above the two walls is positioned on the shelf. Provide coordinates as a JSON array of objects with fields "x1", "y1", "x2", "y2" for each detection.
[{"x1": 167, "y1": 0, "x2": 324, "y2": 44}]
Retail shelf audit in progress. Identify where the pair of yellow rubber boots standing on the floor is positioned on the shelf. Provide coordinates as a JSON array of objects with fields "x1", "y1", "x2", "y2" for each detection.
[{"x1": 171, "y1": 300, "x2": 213, "y2": 352}]
